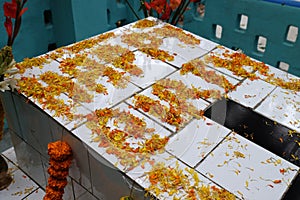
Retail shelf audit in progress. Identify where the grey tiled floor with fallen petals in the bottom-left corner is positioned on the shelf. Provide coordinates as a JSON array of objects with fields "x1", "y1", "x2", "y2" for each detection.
[{"x1": 0, "y1": 147, "x2": 45, "y2": 200}]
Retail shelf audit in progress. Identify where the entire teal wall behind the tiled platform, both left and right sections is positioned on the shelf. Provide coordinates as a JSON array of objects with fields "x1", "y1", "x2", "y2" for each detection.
[{"x1": 0, "y1": 0, "x2": 300, "y2": 76}]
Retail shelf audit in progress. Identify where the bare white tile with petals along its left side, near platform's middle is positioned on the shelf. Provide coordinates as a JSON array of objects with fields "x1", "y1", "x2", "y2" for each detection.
[{"x1": 131, "y1": 51, "x2": 176, "y2": 88}]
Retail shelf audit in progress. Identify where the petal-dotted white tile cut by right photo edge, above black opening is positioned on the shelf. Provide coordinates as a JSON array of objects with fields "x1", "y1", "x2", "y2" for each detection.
[{"x1": 255, "y1": 87, "x2": 300, "y2": 132}]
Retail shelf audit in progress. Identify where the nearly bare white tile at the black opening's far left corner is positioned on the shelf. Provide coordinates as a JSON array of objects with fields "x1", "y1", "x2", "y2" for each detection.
[{"x1": 228, "y1": 79, "x2": 275, "y2": 108}]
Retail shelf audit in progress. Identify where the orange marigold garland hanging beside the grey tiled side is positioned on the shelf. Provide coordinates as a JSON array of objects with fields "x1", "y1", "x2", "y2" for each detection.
[{"x1": 44, "y1": 141, "x2": 72, "y2": 200}]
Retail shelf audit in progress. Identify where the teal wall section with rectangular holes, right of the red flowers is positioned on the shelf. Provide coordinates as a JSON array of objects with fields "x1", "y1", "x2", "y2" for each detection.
[{"x1": 184, "y1": 0, "x2": 300, "y2": 76}]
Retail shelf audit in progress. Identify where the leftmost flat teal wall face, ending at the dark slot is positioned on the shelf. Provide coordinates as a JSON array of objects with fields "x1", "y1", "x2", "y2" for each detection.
[{"x1": 0, "y1": 0, "x2": 54, "y2": 61}]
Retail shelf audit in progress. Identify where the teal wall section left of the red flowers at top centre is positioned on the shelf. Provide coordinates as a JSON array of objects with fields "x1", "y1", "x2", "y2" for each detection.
[{"x1": 0, "y1": 0, "x2": 129, "y2": 61}]
